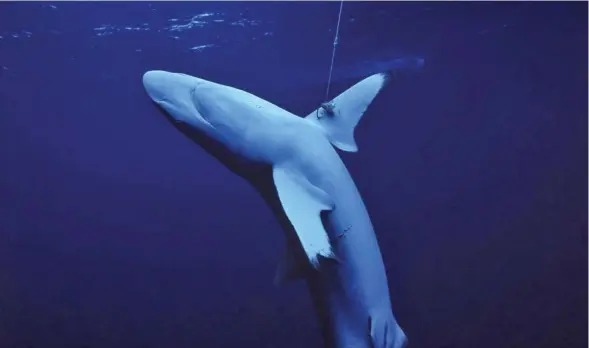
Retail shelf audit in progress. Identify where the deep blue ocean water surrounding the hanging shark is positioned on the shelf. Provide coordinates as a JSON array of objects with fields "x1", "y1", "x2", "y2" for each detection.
[{"x1": 0, "y1": 2, "x2": 588, "y2": 348}]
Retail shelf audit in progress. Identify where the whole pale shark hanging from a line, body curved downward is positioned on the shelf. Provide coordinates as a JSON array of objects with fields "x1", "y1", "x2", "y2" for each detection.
[{"x1": 143, "y1": 71, "x2": 407, "y2": 348}]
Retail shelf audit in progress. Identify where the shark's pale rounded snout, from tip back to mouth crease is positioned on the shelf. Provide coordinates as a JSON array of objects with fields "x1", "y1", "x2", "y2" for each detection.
[{"x1": 143, "y1": 70, "x2": 212, "y2": 131}]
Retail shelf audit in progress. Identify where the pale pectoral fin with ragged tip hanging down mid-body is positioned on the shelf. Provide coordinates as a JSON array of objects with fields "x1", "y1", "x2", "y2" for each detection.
[{"x1": 273, "y1": 165, "x2": 335, "y2": 269}]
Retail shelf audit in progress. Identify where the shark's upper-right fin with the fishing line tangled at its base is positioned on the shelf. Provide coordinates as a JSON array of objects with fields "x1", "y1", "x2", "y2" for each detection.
[{"x1": 305, "y1": 73, "x2": 389, "y2": 152}]
